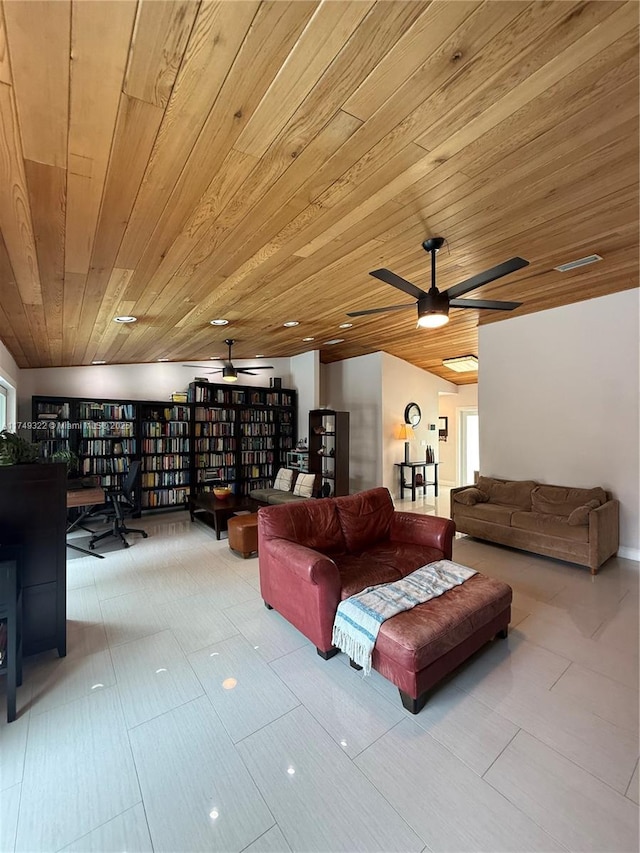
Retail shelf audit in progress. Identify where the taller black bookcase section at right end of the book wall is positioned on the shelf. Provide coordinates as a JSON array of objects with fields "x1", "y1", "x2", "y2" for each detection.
[{"x1": 189, "y1": 382, "x2": 297, "y2": 494}]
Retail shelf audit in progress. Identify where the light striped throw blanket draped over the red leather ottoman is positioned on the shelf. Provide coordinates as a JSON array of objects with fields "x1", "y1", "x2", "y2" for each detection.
[{"x1": 332, "y1": 560, "x2": 476, "y2": 675}]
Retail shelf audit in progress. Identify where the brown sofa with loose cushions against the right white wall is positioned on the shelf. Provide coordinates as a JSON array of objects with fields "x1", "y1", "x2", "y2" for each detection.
[{"x1": 451, "y1": 477, "x2": 620, "y2": 575}]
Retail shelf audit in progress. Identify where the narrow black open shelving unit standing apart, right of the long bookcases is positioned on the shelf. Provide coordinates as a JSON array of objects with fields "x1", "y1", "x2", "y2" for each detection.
[{"x1": 309, "y1": 409, "x2": 349, "y2": 497}]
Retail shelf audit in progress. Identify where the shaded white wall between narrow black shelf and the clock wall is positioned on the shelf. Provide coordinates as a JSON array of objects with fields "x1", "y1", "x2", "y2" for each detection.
[{"x1": 321, "y1": 352, "x2": 382, "y2": 493}]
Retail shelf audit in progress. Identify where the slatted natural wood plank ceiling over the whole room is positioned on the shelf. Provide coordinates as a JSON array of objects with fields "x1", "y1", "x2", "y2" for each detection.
[{"x1": 0, "y1": 0, "x2": 639, "y2": 383}]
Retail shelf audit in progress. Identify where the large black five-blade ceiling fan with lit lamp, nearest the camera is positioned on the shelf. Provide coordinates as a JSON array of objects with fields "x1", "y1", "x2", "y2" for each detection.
[{"x1": 347, "y1": 237, "x2": 529, "y2": 329}]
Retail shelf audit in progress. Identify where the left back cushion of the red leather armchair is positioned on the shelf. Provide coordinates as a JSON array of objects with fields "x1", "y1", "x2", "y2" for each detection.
[{"x1": 258, "y1": 497, "x2": 346, "y2": 555}]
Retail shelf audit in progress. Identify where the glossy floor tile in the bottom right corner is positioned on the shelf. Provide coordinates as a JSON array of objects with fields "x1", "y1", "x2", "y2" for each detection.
[{"x1": 485, "y1": 732, "x2": 638, "y2": 853}]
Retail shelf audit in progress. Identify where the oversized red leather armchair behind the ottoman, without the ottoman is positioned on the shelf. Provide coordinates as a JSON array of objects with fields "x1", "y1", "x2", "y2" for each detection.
[{"x1": 258, "y1": 488, "x2": 455, "y2": 658}]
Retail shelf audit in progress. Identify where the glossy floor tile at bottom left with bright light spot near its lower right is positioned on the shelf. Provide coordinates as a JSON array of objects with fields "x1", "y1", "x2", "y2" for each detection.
[{"x1": 131, "y1": 696, "x2": 274, "y2": 853}]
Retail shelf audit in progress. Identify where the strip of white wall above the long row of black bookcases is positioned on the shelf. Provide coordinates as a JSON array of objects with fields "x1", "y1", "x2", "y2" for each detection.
[{"x1": 19, "y1": 358, "x2": 295, "y2": 420}]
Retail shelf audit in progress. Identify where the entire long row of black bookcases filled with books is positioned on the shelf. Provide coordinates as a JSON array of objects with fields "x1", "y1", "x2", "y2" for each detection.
[{"x1": 32, "y1": 382, "x2": 297, "y2": 509}]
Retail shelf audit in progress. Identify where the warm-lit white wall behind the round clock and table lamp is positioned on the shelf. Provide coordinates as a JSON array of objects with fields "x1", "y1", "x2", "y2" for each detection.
[{"x1": 382, "y1": 353, "x2": 455, "y2": 496}]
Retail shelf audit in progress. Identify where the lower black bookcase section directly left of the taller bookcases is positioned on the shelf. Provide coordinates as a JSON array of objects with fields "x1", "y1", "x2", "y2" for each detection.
[{"x1": 140, "y1": 402, "x2": 191, "y2": 509}]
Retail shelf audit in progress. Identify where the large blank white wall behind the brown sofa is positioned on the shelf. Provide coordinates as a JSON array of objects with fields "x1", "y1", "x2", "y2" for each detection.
[{"x1": 478, "y1": 290, "x2": 640, "y2": 559}]
